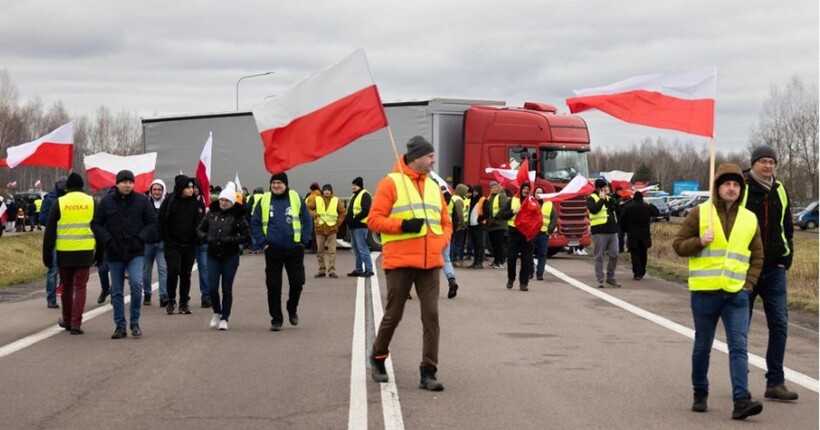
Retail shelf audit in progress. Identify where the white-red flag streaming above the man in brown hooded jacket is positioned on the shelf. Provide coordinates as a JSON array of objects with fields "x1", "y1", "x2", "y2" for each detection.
[{"x1": 567, "y1": 68, "x2": 717, "y2": 137}]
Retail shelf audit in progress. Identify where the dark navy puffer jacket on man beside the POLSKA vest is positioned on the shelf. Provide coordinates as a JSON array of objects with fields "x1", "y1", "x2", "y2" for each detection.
[{"x1": 91, "y1": 186, "x2": 159, "y2": 261}]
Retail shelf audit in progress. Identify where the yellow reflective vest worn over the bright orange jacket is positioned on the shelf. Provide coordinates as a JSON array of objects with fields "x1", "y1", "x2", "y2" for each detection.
[{"x1": 381, "y1": 172, "x2": 444, "y2": 245}]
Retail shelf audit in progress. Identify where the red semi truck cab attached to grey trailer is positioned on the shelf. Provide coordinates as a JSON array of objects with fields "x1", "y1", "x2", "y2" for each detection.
[{"x1": 464, "y1": 102, "x2": 592, "y2": 255}]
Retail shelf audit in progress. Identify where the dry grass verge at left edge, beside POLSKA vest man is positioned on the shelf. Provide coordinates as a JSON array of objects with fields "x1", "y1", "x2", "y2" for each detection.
[{"x1": 0, "y1": 231, "x2": 47, "y2": 288}]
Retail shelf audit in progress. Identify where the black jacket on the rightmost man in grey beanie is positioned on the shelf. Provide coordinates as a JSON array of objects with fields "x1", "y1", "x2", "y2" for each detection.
[{"x1": 744, "y1": 170, "x2": 794, "y2": 270}]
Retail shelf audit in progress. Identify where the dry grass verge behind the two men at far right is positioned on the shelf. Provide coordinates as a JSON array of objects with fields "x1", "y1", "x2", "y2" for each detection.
[{"x1": 640, "y1": 223, "x2": 818, "y2": 313}]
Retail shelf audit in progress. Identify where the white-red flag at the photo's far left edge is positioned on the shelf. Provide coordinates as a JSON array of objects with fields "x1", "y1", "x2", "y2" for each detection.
[{"x1": 0, "y1": 121, "x2": 74, "y2": 169}]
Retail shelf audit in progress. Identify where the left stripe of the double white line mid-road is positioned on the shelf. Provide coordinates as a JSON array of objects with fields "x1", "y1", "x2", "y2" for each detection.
[{"x1": 347, "y1": 277, "x2": 367, "y2": 430}]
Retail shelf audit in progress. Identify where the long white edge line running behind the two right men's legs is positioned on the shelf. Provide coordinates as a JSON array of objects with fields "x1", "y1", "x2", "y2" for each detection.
[{"x1": 546, "y1": 266, "x2": 820, "y2": 393}]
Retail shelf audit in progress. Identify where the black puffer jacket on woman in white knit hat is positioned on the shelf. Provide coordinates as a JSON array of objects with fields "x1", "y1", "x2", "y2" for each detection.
[{"x1": 197, "y1": 200, "x2": 251, "y2": 258}]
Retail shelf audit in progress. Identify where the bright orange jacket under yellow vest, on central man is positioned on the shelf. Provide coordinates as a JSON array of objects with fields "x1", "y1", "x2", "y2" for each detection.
[{"x1": 367, "y1": 157, "x2": 453, "y2": 270}]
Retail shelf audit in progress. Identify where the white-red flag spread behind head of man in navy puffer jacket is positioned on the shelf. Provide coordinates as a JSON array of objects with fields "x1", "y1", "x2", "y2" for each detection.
[{"x1": 83, "y1": 152, "x2": 157, "y2": 193}]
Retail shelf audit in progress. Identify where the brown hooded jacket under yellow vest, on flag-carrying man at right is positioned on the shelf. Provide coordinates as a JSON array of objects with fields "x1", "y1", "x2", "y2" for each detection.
[{"x1": 672, "y1": 164, "x2": 763, "y2": 290}]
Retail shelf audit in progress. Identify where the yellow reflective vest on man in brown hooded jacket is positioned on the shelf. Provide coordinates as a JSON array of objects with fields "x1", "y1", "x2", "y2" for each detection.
[{"x1": 689, "y1": 200, "x2": 757, "y2": 293}]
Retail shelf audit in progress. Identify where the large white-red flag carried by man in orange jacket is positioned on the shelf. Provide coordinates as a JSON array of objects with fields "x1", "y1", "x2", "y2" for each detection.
[{"x1": 253, "y1": 49, "x2": 387, "y2": 173}]
